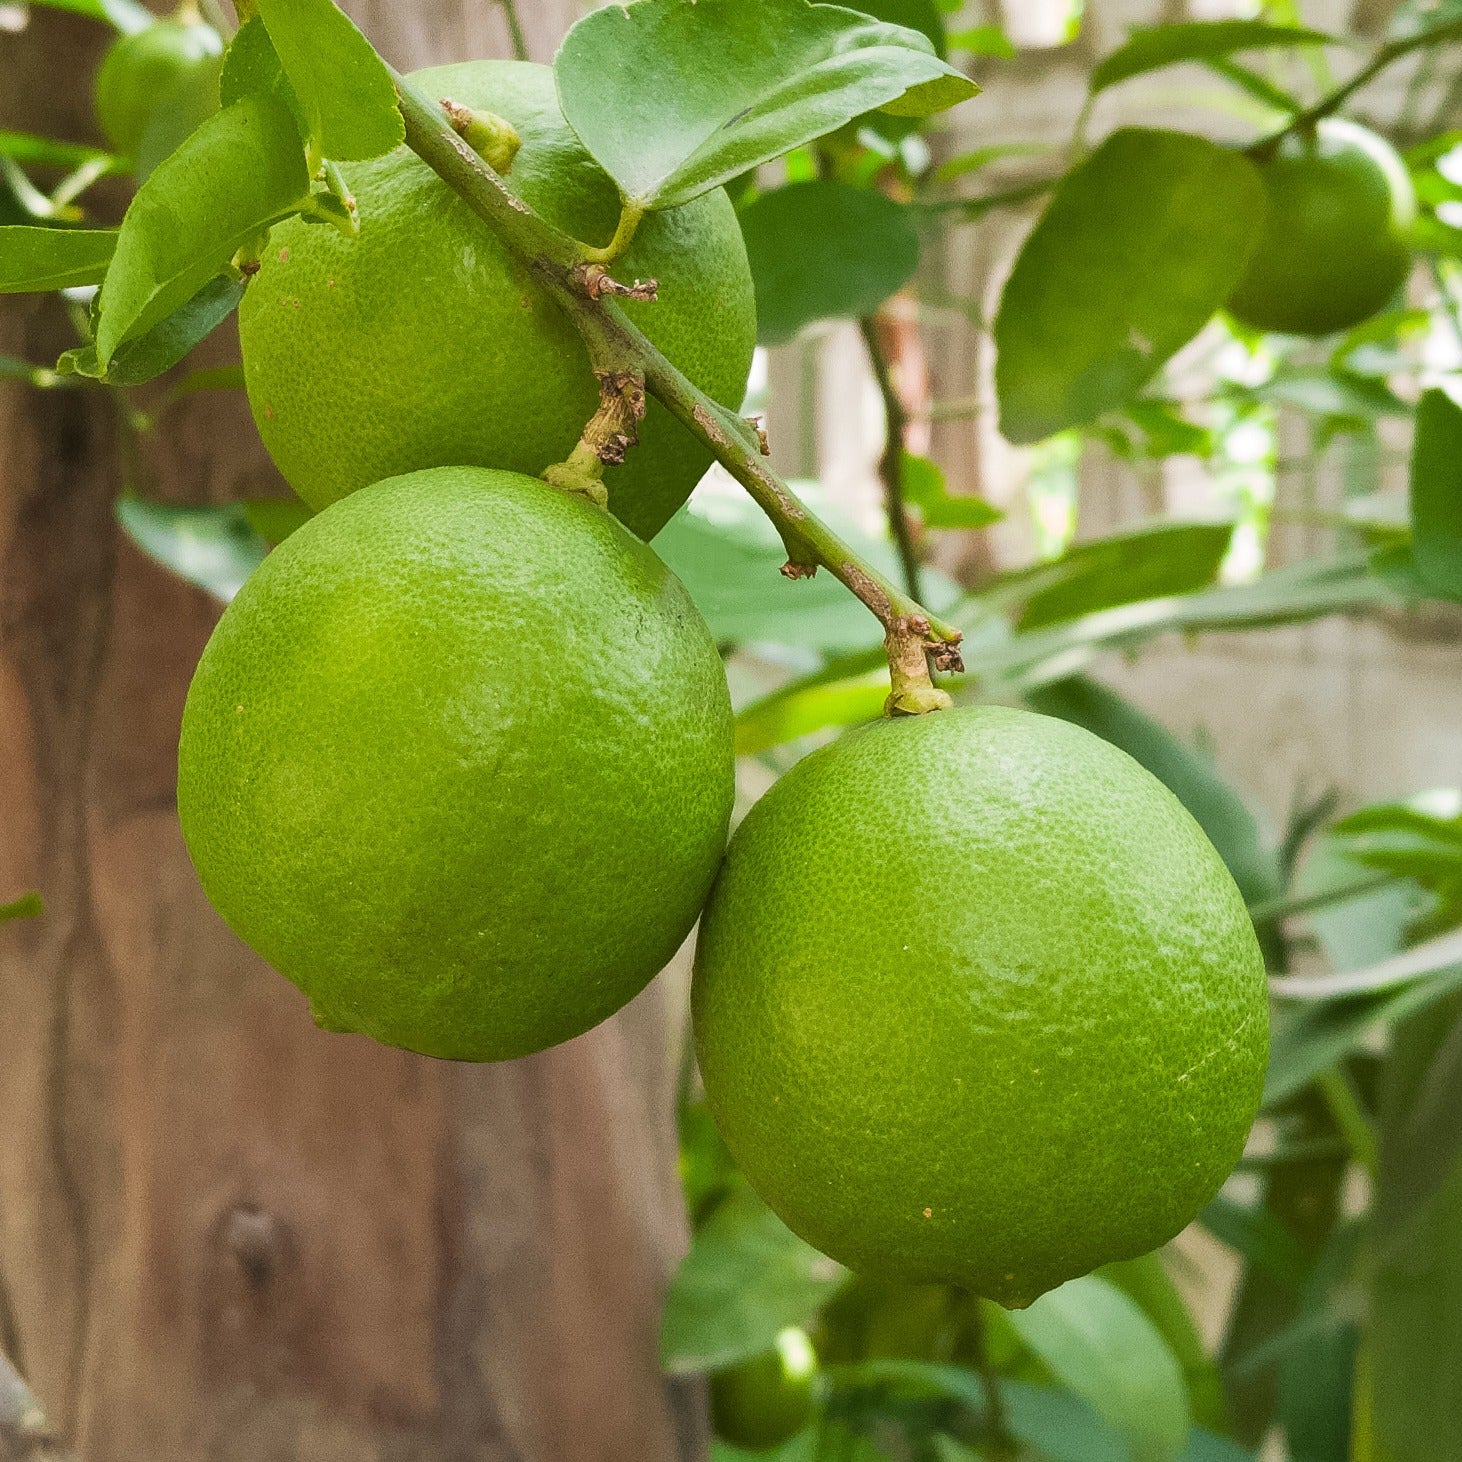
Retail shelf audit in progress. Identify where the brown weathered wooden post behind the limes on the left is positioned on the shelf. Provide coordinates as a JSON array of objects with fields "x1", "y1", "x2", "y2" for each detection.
[{"x1": 0, "y1": 0, "x2": 705, "y2": 1462}]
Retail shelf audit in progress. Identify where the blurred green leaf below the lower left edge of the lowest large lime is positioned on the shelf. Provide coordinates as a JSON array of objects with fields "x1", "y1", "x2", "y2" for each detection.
[{"x1": 659, "y1": 1187, "x2": 848, "y2": 1374}]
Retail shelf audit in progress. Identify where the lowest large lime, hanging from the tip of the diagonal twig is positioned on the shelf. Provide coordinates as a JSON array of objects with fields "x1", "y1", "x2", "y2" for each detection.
[{"x1": 693, "y1": 708, "x2": 1269, "y2": 1306}]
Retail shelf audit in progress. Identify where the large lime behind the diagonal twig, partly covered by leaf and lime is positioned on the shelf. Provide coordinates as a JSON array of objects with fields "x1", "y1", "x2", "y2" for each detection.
[{"x1": 238, "y1": 61, "x2": 756, "y2": 538}]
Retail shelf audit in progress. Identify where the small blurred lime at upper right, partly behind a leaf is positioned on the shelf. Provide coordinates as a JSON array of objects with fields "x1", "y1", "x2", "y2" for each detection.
[{"x1": 1228, "y1": 117, "x2": 1417, "y2": 335}]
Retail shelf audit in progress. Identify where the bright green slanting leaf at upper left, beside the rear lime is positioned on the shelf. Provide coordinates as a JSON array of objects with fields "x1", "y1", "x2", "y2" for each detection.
[{"x1": 96, "y1": 96, "x2": 310, "y2": 366}]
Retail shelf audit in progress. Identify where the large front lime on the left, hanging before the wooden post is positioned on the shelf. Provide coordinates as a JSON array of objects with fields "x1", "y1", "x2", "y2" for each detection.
[{"x1": 178, "y1": 468, "x2": 734, "y2": 1061}]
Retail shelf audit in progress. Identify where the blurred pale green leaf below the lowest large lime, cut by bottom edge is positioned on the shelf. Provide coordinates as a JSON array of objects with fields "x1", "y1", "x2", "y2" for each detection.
[{"x1": 1010, "y1": 1275, "x2": 1189, "y2": 1462}]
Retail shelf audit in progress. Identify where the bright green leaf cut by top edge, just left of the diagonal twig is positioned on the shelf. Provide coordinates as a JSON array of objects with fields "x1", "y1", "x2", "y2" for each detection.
[{"x1": 257, "y1": 0, "x2": 406, "y2": 162}]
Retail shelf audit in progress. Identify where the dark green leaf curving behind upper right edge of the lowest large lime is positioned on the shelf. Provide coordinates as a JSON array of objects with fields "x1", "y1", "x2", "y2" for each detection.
[{"x1": 1025, "y1": 675, "x2": 1279, "y2": 904}]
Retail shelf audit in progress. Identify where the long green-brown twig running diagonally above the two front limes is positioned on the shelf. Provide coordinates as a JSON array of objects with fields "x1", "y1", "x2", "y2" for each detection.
[{"x1": 393, "y1": 73, "x2": 961, "y2": 683}]
